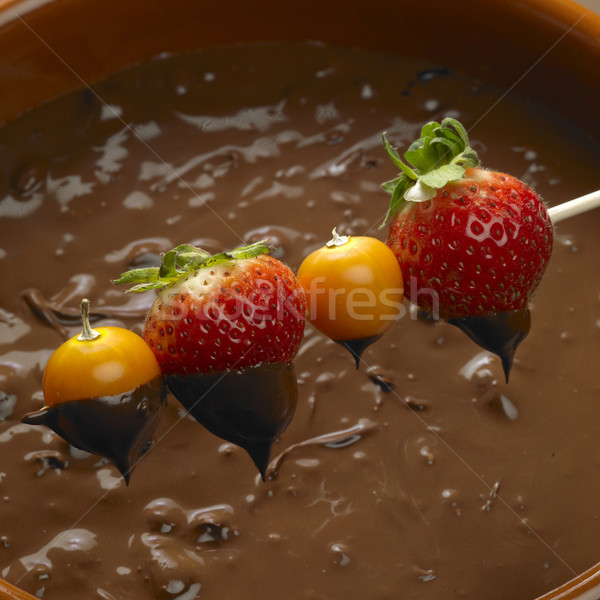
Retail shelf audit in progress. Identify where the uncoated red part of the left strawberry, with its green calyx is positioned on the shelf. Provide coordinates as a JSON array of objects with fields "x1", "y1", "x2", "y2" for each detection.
[{"x1": 116, "y1": 242, "x2": 306, "y2": 375}]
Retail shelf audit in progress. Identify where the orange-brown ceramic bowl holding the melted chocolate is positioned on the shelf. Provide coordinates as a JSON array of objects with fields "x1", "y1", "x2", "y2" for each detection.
[{"x1": 0, "y1": 0, "x2": 600, "y2": 600}]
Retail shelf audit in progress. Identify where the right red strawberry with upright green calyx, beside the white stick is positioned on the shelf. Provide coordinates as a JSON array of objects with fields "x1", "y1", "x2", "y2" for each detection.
[{"x1": 383, "y1": 119, "x2": 553, "y2": 372}]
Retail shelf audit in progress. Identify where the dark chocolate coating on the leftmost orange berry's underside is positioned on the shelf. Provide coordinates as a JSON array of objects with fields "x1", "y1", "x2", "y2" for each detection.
[{"x1": 21, "y1": 377, "x2": 166, "y2": 485}]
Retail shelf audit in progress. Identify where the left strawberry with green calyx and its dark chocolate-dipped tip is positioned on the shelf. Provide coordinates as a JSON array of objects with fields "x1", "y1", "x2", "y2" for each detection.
[{"x1": 115, "y1": 241, "x2": 306, "y2": 477}]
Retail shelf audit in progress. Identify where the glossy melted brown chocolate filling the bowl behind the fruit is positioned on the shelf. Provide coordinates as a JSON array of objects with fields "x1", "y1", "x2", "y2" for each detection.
[{"x1": 0, "y1": 44, "x2": 600, "y2": 600}]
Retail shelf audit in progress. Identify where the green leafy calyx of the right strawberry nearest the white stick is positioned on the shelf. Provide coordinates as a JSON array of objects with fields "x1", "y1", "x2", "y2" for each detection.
[{"x1": 381, "y1": 118, "x2": 479, "y2": 226}]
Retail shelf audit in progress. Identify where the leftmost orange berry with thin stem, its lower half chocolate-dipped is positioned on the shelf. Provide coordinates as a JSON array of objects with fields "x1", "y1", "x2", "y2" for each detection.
[{"x1": 22, "y1": 299, "x2": 165, "y2": 483}]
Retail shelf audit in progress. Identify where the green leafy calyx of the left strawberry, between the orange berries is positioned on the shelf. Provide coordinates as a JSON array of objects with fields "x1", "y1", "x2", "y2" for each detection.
[{"x1": 113, "y1": 240, "x2": 272, "y2": 292}]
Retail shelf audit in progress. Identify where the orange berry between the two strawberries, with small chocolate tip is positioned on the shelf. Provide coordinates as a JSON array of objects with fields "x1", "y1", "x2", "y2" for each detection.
[{"x1": 298, "y1": 229, "x2": 404, "y2": 368}]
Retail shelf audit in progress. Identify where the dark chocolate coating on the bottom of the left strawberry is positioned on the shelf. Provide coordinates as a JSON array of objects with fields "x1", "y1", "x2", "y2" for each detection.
[{"x1": 167, "y1": 363, "x2": 298, "y2": 479}]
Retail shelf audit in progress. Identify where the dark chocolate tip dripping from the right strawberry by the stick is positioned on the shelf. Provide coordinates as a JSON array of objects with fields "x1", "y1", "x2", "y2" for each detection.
[{"x1": 448, "y1": 308, "x2": 531, "y2": 383}]
